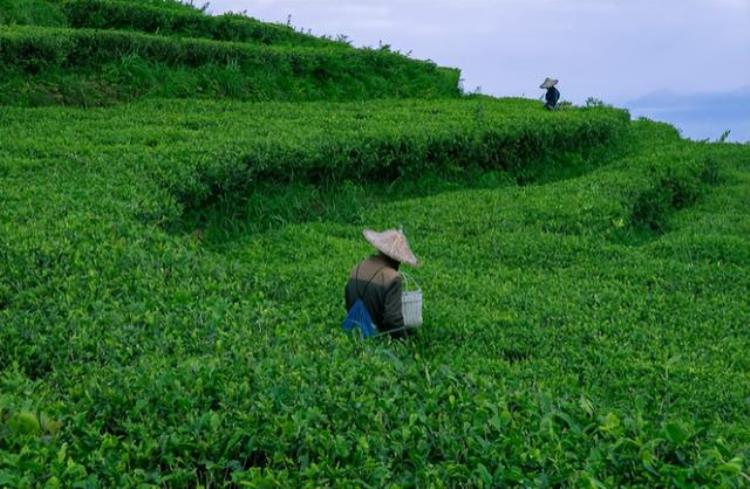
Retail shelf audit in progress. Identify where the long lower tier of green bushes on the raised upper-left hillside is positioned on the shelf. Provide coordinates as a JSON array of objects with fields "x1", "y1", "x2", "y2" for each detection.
[{"x1": 0, "y1": 27, "x2": 458, "y2": 106}]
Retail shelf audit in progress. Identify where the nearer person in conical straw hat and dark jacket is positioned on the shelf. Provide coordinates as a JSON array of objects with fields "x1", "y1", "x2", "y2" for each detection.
[{"x1": 344, "y1": 229, "x2": 417, "y2": 338}]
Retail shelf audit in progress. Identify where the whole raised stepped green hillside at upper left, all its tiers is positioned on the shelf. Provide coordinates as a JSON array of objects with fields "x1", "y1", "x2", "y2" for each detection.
[{"x1": 0, "y1": 0, "x2": 459, "y2": 106}]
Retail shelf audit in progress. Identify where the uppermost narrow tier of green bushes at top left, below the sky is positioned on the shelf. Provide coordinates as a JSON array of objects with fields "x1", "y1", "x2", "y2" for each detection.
[{"x1": 62, "y1": 0, "x2": 348, "y2": 47}]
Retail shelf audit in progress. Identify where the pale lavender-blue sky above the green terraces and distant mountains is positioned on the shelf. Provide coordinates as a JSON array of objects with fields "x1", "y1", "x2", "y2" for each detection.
[{"x1": 209, "y1": 0, "x2": 750, "y2": 104}]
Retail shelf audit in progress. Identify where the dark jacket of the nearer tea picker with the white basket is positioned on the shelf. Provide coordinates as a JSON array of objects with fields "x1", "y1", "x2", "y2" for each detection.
[{"x1": 344, "y1": 255, "x2": 404, "y2": 336}]
